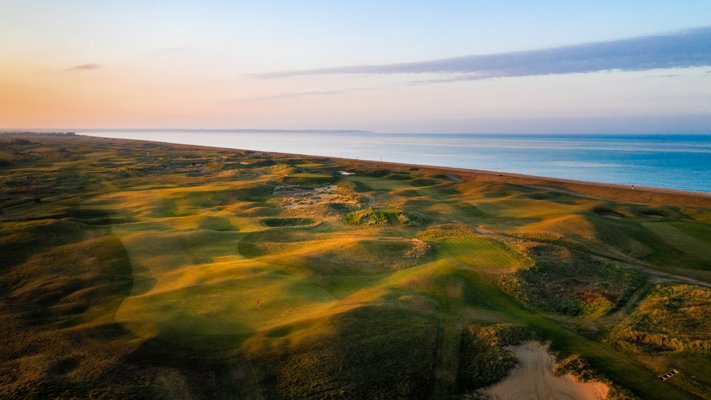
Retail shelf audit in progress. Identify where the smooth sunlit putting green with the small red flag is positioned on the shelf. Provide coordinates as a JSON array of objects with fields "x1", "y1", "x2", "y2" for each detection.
[{"x1": 116, "y1": 261, "x2": 342, "y2": 337}]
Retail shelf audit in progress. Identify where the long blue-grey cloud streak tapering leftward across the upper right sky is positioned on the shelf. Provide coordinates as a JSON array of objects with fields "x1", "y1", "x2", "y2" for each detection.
[{"x1": 256, "y1": 27, "x2": 711, "y2": 79}]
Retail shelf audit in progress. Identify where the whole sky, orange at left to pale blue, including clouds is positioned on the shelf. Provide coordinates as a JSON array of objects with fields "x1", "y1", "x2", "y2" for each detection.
[{"x1": 0, "y1": 0, "x2": 711, "y2": 133}]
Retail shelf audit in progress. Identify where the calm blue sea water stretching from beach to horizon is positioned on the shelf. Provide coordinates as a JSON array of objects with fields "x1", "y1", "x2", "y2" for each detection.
[{"x1": 77, "y1": 130, "x2": 711, "y2": 192}]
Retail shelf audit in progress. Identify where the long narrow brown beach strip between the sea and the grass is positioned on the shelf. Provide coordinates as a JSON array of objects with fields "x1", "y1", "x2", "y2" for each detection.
[{"x1": 4, "y1": 132, "x2": 711, "y2": 208}]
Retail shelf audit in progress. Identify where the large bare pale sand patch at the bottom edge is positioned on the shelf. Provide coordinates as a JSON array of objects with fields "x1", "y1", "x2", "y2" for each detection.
[{"x1": 483, "y1": 341, "x2": 609, "y2": 400}]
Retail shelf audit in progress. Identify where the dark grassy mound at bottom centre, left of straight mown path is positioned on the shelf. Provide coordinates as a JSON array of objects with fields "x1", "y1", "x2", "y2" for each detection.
[{"x1": 245, "y1": 307, "x2": 437, "y2": 399}]
